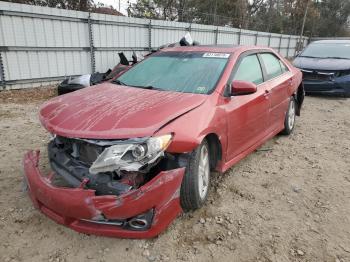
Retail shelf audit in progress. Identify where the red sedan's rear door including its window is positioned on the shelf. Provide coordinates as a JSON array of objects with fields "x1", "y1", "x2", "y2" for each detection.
[{"x1": 259, "y1": 52, "x2": 293, "y2": 133}]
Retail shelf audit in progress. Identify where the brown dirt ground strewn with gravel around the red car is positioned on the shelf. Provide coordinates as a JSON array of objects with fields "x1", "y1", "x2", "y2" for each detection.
[{"x1": 0, "y1": 89, "x2": 350, "y2": 262}]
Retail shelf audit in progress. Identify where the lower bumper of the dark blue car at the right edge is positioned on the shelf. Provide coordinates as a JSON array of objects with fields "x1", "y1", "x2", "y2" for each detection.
[{"x1": 303, "y1": 80, "x2": 350, "y2": 96}]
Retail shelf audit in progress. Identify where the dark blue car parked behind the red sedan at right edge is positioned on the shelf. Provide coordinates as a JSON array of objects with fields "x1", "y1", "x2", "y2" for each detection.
[{"x1": 293, "y1": 40, "x2": 350, "y2": 97}]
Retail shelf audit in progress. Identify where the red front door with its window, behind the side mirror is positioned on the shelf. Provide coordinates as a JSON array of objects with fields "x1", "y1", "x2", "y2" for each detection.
[{"x1": 225, "y1": 54, "x2": 269, "y2": 161}]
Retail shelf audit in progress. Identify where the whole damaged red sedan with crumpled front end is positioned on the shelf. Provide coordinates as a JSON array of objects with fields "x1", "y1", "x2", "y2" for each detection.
[{"x1": 24, "y1": 46, "x2": 304, "y2": 238}]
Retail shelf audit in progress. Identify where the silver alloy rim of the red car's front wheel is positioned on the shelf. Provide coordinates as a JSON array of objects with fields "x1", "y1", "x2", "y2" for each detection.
[{"x1": 198, "y1": 146, "x2": 210, "y2": 200}]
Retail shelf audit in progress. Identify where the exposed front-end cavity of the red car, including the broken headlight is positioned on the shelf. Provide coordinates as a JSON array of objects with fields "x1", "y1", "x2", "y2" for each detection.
[{"x1": 48, "y1": 136, "x2": 187, "y2": 195}]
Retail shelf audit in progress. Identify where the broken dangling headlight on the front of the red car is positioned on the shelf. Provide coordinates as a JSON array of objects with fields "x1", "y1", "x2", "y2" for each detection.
[{"x1": 89, "y1": 134, "x2": 172, "y2": 174}]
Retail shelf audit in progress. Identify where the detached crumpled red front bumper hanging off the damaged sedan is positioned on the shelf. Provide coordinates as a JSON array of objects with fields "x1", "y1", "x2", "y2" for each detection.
[{"x1": 24, "y1": 151, "x2": 185, "y2": 238}]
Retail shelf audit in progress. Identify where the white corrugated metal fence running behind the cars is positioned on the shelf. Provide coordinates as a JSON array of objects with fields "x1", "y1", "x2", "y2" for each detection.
[{"x1": 0, "y1": 2, "x2": 307, "y2": 90}]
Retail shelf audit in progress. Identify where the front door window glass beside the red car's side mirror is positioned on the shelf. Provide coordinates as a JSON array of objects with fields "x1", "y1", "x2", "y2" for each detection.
[{"x1": 233, "y1": 55, "x2": 264, "y2": 85}]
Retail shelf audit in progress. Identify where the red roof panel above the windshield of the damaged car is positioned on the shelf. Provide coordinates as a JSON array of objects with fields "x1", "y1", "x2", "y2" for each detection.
[{"x1": 161, "y1": 45, "x2": 271, "y2": 53}]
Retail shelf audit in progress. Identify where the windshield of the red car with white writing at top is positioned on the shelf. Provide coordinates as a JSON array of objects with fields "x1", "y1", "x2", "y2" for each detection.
[{"x1": 114, "y1": 52, "x2": 229, "y2": 94}]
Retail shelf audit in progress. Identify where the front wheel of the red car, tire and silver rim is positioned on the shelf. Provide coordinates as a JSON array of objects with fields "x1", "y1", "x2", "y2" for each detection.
[{"x1": 180, "y1": 140, "x2": 210, "y2": 211}]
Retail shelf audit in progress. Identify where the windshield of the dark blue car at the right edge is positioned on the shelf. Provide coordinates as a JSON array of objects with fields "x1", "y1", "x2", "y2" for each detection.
[{"x1": 300, "y1": 42, "x2": 350, "y2": 59}]
